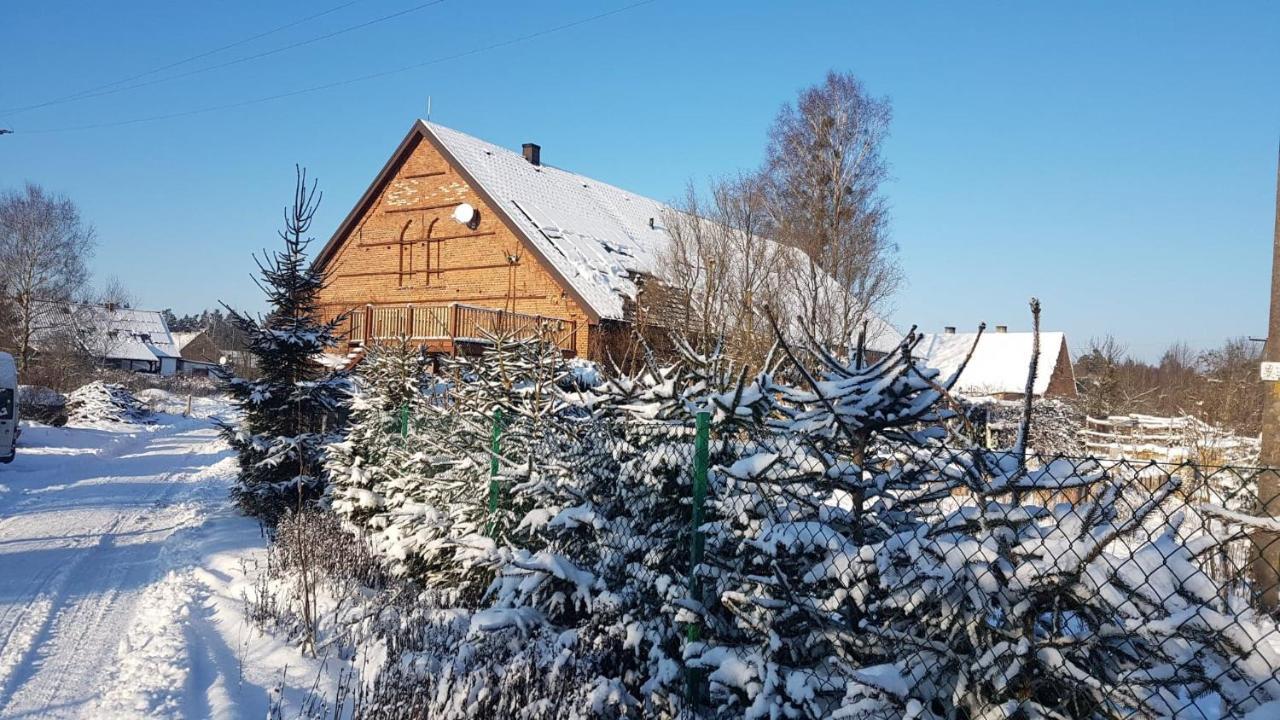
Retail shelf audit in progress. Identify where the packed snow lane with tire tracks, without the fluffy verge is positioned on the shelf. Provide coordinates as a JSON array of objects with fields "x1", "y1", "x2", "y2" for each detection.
[{"x1": 0, "y1": 421, "x2": 224, "y2": 716}]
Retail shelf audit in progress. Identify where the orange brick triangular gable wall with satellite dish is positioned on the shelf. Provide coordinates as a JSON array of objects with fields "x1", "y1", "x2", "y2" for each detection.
[{"x1": 315, "y1": 122, "x2": 599, "y2": 352}]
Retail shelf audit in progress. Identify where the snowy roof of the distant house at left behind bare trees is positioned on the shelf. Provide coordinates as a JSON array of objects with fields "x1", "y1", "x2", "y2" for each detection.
[{"x1": 37, "y1": 302, "x2": 180, "y2": 361}]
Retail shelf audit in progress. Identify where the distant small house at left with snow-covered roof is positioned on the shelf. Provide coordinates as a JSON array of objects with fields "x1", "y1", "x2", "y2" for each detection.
[{"x1": 32, "y1": 302, "x2": 182, "y2": 375}]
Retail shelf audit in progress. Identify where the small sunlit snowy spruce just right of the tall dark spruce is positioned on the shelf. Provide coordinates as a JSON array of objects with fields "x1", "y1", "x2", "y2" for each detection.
[{"x1": 325, "y1": 338, "x2": 430, "y2": 532}]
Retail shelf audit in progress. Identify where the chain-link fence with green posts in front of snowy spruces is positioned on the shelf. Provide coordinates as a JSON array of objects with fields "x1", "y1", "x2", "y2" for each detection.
[{"x1": 509, "y1": 415, "x2": 1280, "y2": 719}]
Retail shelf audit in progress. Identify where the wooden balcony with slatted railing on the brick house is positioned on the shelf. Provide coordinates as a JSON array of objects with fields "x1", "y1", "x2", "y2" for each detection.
[{"x1": 339, "y1": 302, "x2": 577, "y2": 355}]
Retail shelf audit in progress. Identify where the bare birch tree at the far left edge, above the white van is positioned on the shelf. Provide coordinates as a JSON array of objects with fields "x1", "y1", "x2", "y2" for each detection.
[{"x1": 0, "y1": 183, "x2": 93, "y2": 373}]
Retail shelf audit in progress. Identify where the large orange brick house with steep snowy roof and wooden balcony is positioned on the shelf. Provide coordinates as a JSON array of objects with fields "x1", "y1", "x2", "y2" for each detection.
[{"x1": 315, "y1": 120, "x2": 901, "y2": 357}]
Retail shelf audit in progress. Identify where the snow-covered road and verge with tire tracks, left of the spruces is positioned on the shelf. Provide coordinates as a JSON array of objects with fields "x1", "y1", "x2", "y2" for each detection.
[{"x1": 0, "y1": 399, "x2": 335, "y2": 717}]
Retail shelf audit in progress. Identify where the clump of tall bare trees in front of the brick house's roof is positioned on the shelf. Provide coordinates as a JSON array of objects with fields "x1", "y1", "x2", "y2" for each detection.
[{"x1": 650, "y1": 73, "x2": 900, "y2": 364}]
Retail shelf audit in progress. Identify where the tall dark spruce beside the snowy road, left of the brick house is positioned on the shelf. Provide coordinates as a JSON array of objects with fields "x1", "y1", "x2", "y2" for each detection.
[{"x1": 219, "y1": 168, "x2": 347, "y2": 524}]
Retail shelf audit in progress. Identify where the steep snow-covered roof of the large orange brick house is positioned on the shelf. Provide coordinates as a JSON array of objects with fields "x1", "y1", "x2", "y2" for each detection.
[{"x1": 320, "y1": 120, "x2": 901, "y2": 350}]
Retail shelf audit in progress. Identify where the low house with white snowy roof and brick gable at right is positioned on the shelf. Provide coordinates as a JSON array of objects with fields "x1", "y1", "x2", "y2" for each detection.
[{"x1": 915, "y1": 325, "x2": 1075, "y2": 400}]
